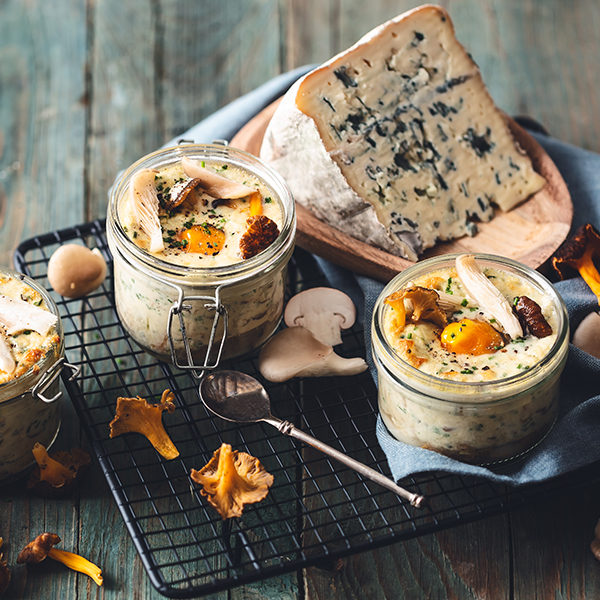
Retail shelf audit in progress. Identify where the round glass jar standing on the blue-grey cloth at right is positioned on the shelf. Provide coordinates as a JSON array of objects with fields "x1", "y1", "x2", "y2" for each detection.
[{"x1": 372, "y1": 254, "x2": 569, "y2": 464}]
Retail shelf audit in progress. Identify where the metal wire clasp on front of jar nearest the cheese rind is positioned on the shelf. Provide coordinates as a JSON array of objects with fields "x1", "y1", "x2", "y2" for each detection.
[{"x1": 167, "y1": 286, "x2": 228, "y2": 379}]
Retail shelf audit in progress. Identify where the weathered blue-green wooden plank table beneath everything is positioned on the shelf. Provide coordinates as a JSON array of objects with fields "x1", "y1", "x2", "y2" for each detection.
[{"x1": 0, "y1": 0, "x2": 600, "y2": 600}]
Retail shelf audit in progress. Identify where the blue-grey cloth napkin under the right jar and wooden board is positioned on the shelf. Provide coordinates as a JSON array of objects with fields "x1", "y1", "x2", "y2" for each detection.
[{"x1": 170, "y1": 66, "x2": 600, "y2": 485}]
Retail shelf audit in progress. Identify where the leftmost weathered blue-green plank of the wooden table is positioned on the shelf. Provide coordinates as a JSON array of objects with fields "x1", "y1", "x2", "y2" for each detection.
[{"x1": 0, "y1": 0, "x2": 86, "y2": 598}]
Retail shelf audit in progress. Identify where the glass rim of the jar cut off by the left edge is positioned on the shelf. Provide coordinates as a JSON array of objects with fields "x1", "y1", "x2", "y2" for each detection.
[{"x1": 0, "y1": 268, "x2": 65, "y2": 406}]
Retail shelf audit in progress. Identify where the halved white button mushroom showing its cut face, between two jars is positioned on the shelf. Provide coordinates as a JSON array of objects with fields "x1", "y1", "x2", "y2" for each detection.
[{"x1": 283, "y1": 287, "x2": 356, "y2": 346}]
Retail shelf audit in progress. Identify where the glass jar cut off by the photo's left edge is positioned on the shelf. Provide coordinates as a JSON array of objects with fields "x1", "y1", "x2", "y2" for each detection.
[{"x1": 0, "y1": 269, "x2": 71, "y2": 480}]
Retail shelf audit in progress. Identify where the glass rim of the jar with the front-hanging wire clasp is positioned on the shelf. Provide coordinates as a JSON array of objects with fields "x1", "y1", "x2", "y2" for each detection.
[{"x1": 108, "y1": 143, "x2": 296, "y2": 282}]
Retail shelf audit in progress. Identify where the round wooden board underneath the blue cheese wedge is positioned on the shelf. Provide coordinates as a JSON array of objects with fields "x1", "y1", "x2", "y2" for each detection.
[{"x1": 231, "y1": 100, "x2": 573, "y2": 281}]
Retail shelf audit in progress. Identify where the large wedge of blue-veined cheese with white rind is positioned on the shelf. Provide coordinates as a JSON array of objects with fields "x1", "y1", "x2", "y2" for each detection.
[{"x1": 261, "y1": 5, "x2": 545, "y2": 260}]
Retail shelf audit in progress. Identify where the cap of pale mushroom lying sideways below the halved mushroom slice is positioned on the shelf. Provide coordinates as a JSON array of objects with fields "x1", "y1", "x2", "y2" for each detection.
[{"x1": 258, "y1": 327, "x2": 333, "y2": 382}]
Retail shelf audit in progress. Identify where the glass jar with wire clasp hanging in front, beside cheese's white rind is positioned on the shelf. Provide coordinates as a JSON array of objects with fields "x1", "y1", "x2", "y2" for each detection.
[{"x1": 106, "y1": 144, "x2": 296, "y2": 376}]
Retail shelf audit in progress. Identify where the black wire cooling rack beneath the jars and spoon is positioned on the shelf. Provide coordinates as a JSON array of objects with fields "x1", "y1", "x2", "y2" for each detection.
[{"x1": 14, "y1": 221, "x2": 600, "y2": 598}]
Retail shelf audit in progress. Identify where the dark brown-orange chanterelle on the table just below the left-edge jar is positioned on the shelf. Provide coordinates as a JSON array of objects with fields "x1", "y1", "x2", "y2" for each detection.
[{"x1": 27, "y1": 442, "x2": 90, "y2": 496}]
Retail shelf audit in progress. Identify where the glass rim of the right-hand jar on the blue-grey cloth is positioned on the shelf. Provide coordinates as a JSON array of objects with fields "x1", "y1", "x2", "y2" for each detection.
[{"x1": 371, "y1": 253, "x2": 569, "y2": 398}]
